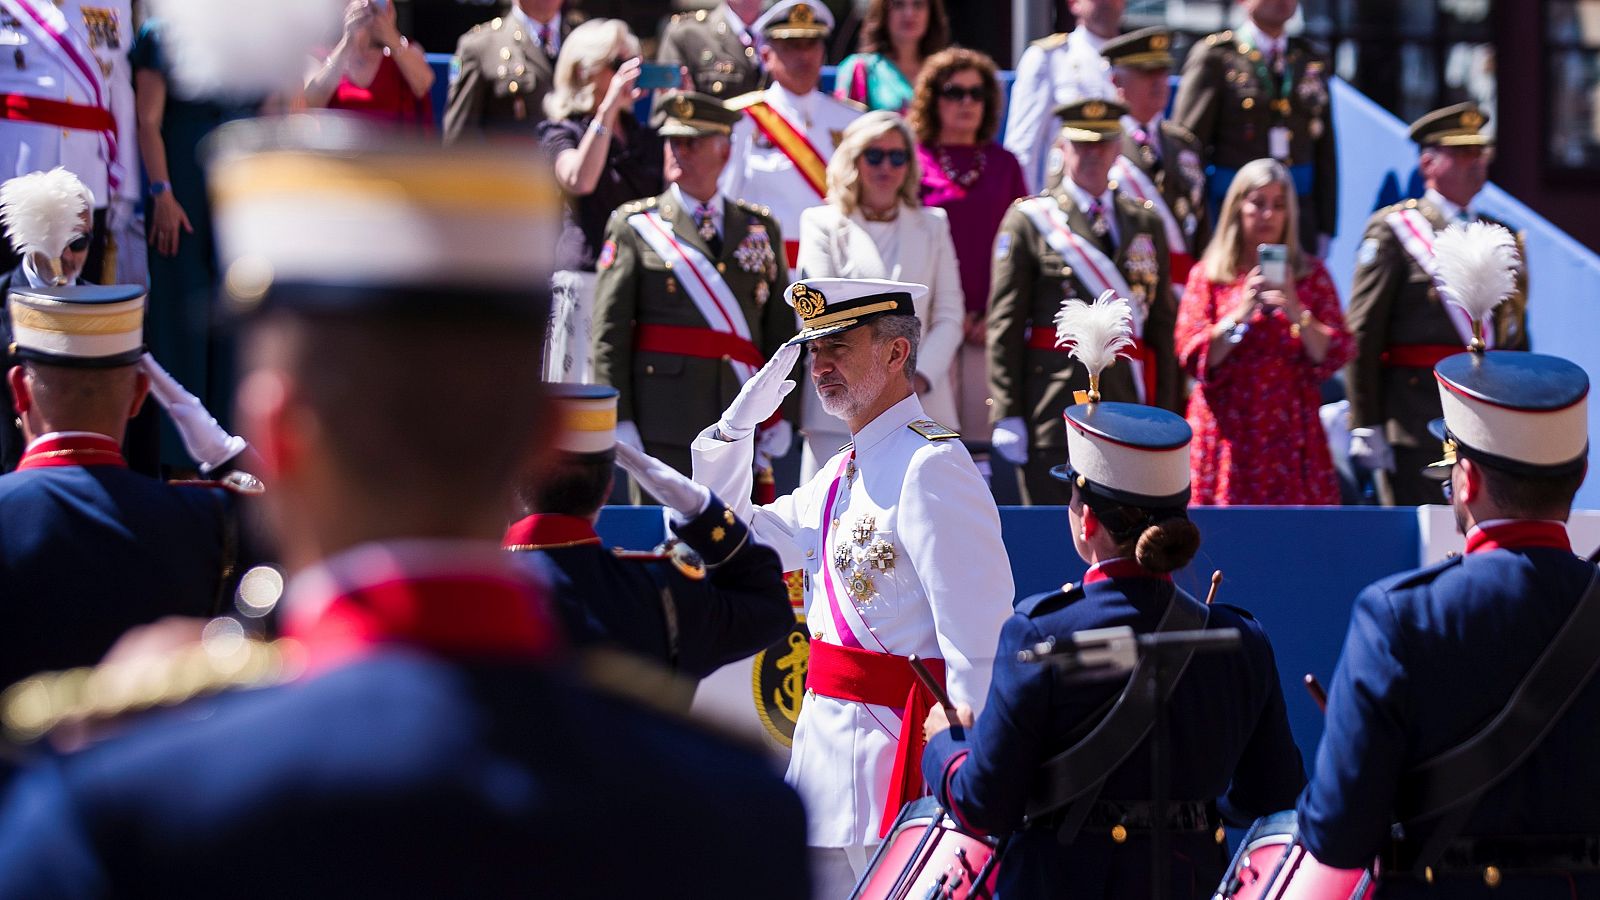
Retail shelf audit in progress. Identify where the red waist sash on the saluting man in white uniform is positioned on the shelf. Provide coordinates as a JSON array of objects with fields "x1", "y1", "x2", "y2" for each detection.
[{"x1": 805, "y1": 641, "x2": 944, "y2": 838}]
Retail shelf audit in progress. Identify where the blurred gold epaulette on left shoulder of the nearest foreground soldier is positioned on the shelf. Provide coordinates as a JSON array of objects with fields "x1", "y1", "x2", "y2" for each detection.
[{"x1": 0, "y1": 620, "x2": 306, "y2": 743}]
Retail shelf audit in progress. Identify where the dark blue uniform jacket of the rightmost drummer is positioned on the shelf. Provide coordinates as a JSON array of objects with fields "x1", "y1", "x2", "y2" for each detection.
[{"x1": 1299, "y1": 534, "x2": 1600, "y2": 898}]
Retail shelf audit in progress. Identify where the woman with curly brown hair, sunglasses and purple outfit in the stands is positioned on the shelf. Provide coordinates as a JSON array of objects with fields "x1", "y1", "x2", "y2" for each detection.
[{"x1": 909, "y1": 50, "x2": 1027, "y2": 434}]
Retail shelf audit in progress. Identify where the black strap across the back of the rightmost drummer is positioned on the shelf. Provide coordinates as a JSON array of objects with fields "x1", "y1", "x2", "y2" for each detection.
[{"x1": 1395, "y1": 570, "x2": 1600, "y2": 874}]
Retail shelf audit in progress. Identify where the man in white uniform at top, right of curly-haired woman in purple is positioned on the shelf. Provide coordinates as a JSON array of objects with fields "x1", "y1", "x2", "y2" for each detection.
[{"x1": 1005, "y1": 0, "x2": 1128, "y2": 194}]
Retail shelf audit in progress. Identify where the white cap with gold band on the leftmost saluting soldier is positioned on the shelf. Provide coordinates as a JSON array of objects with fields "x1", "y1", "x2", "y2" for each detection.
[{"x1": 6, "y1": 285, "x2": 144, "y2": 368}]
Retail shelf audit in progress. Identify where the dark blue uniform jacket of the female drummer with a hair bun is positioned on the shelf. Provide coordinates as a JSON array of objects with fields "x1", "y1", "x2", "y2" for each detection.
[{"x1": 923, "y1": 566, "x2": 1306, "y2": 898}]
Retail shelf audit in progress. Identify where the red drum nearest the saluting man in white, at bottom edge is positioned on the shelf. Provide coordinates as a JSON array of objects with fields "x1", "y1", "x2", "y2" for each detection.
[{"x1": 850, "y1": 798, "x2": 1003, "y2": 900}]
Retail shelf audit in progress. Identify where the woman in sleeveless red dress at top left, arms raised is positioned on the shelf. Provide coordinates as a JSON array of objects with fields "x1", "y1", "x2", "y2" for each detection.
[{"x1": 306, "y1": 0, "x2": 434, "y2": 131}]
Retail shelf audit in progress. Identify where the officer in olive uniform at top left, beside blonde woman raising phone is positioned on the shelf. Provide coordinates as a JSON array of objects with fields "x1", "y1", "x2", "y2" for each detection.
[{"x1": 443, "y1": 0, "x2": 571, "y2": 144}]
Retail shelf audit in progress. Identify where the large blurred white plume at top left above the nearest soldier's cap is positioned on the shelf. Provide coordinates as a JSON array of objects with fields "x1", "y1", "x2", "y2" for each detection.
[{"x1": 150, "y1": 0, "x2": 344, "y2": 101}]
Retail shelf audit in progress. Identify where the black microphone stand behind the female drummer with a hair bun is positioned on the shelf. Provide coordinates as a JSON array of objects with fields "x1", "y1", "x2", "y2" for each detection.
[{"x1": 1016, "y1": 626, "x2": 1242, "y2": 900}]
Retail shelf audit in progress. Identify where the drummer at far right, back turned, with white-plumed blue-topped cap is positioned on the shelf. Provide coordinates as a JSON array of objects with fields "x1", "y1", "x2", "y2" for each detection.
[{"x1": 1299, "y1": 224, "x2": 1600, "y2": 900}]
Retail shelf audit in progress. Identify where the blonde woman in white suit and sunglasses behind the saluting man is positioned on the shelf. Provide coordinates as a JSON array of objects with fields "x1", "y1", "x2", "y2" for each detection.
[{"x1": 795, "y1": 110, "x2": 965, "y2": 480}]
